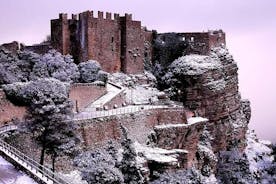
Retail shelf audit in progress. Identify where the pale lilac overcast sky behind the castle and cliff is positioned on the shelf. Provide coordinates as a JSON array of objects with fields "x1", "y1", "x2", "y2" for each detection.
[{"x1": 0, "y1": 0, "x2": 276, "y2": 141}]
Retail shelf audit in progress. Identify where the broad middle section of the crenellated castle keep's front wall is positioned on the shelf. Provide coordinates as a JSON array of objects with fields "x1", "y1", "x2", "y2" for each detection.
[{"x1": 76, "y1": 11, "x2": 121, "y2": 72}]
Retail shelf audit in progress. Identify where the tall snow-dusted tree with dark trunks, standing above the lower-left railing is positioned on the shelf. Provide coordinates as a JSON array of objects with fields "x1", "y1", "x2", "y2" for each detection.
[{"x1": 4, "y1": 78, "x2": 77, "y2": 169}]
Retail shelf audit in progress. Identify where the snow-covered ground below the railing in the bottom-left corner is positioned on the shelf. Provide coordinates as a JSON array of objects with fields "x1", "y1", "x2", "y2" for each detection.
[{"x1": 0, "y1": 157, "x2": 37, "y2": 184}]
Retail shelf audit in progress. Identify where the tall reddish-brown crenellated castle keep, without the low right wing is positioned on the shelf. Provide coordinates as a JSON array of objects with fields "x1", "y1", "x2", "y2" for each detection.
[{"x1": 51, "y1": 11, "x2": 151, "y2": 73}]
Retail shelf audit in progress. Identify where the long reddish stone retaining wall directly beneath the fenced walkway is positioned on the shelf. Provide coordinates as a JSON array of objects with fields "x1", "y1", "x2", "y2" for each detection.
[{"x1": 77, "y1": 108, "x2": 186, "y2": 149}]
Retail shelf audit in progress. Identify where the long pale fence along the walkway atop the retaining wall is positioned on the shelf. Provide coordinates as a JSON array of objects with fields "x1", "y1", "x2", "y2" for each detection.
[{"x1": 74, "y1": 105, "x2": 182, "y2": 120}]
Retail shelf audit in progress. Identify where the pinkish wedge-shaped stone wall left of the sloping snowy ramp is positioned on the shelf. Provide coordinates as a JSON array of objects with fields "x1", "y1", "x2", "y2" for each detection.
[{"x1": 69, "y1": 83, "x2": 106, "y2": 112}]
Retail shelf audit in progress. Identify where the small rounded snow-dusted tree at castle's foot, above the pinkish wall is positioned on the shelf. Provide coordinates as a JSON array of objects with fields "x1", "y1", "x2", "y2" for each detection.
[{"x1": 79, "y1": 60, "x2": 107, "y2": 83}]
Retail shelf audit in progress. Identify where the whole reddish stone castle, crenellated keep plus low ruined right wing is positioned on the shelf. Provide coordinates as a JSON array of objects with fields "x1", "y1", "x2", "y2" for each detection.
[{"x1": 51, "y1": 11, "x2": 225, "y2": 74}]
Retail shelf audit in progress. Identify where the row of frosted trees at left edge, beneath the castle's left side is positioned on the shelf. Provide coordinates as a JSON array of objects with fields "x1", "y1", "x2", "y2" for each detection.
[{"x1": 0, "y1": 48, "x2": 79, "y2": 85}]
